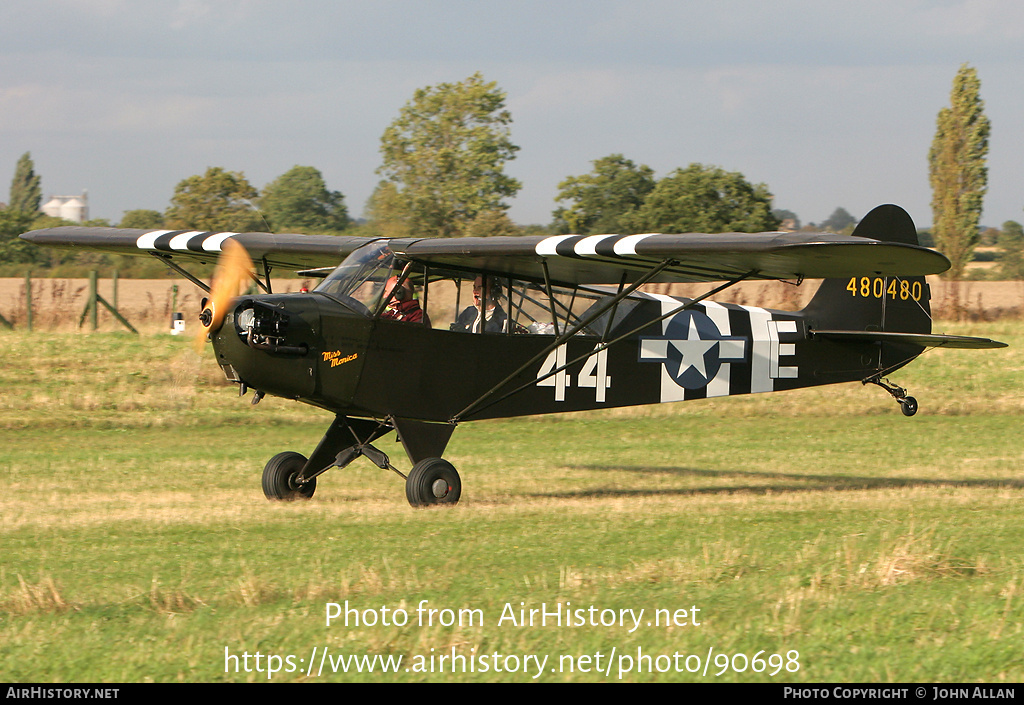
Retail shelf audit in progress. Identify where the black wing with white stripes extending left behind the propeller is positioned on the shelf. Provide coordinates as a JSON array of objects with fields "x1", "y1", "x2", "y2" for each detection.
[{"x1": 22, "y1": 225, "x2": 376, "y2": 269}]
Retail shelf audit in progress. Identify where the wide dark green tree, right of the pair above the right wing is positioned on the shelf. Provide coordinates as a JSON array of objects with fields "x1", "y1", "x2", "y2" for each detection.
[{"x1": 624, "y1": 164, "x2": 778, "y2": 233}]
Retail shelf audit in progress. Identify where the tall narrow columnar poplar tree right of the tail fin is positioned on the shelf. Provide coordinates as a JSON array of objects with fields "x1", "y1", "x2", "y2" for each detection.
[{"x1": 928, "y1": 64, "x2": 991, "y2": 279}]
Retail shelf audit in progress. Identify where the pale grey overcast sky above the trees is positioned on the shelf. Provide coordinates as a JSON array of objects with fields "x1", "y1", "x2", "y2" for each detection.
[{"x1": 0, "y1": 0, "x2": 1024, "y2": 225}]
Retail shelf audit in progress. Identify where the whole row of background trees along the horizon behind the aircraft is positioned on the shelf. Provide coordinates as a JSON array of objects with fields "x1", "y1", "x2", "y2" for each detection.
[{"x1": 0, "y1": 65, "x2": 1024, "y2": 279}]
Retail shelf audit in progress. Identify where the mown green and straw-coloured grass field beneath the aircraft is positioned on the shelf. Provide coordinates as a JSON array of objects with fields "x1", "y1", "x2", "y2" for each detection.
[{"x1": 0, "y1": 322, "x2": 1024, "y2": 682}]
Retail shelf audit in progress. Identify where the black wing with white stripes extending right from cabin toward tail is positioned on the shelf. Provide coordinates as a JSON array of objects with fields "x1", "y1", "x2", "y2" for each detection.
[{"x1": 391, "y1": 232, "x2": 949, "y2": 285}]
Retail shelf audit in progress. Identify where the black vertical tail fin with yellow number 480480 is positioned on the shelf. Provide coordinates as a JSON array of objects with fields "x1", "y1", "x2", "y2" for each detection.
[{"x1": 804, "y1": 205, "x2": 932, "y2": 333}]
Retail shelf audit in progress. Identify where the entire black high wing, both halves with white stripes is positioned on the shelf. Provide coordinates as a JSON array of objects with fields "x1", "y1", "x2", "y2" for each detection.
[{"x1": 22, "y1": 226, "x2": 949, "y2": 286}]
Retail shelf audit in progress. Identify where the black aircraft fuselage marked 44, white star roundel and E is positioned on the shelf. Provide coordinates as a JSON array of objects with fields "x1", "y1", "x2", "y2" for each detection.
[{"x1": 213, "y1": 294, "x2": 923, "y2": 421}]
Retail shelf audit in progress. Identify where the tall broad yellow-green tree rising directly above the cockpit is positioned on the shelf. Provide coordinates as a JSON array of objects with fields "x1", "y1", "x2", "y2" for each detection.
[{"x1": 378, "y1": 73, "x2": 521, "y2": 237}]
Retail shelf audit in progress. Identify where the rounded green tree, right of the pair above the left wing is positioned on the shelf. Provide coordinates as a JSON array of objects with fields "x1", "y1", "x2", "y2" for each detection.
[{"x1": 259, "y1": 166, "x2": 349, "y2": 233}]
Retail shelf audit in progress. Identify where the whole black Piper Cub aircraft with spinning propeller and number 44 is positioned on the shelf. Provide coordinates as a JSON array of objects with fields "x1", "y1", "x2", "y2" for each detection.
[{"x1": 22, "y1": 205, "x2": 1005, "y2": 506}]
